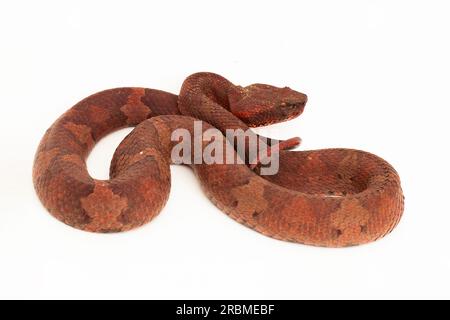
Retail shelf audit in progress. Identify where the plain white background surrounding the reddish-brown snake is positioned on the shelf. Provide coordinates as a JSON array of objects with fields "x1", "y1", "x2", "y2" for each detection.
[{"x1": 0, "y1": 0, "x2": 450, "y2": 299}]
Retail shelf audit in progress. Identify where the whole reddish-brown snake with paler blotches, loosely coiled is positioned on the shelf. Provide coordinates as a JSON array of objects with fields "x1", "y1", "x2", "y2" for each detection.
[{"x1": 33, "y1": 72, "x2": 404, "y2": 248}]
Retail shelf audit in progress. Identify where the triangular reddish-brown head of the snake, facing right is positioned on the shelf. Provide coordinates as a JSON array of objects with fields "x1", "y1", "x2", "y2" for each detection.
[{"x1": 230, "y1": 83, "x2": 308, "y2": 127}]
